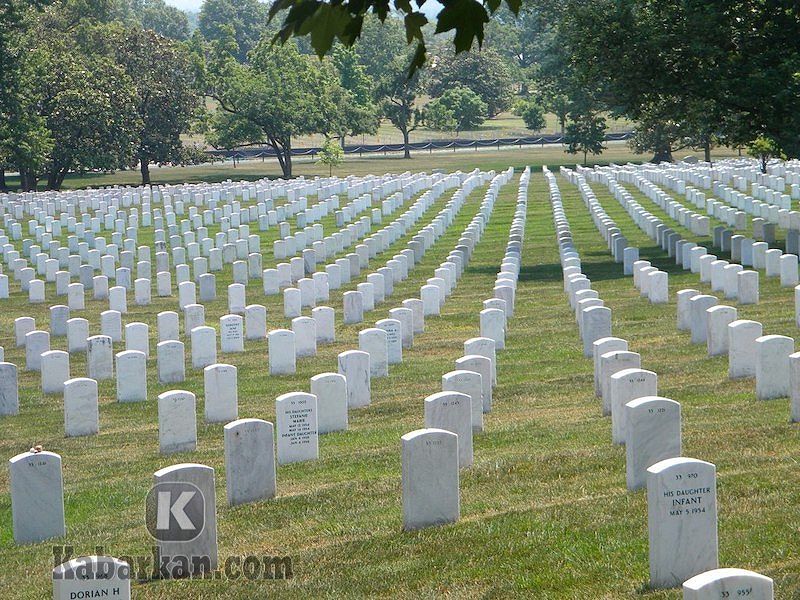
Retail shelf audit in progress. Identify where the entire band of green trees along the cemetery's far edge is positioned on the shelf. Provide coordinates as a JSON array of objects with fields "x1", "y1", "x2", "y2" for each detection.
[{"x1": 7, "y1": 0, "x2": 800, "y2": 190}]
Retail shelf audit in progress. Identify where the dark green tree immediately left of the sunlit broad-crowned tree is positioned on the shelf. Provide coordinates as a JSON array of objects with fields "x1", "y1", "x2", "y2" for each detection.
[{"x1": 111, "y1": 29, "x2": 201, "y2": 185}]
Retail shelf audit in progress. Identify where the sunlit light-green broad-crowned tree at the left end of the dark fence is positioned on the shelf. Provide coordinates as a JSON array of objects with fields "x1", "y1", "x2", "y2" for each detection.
[{"x1": 208, "y1": 40, "x2": 339, "y2": 178}]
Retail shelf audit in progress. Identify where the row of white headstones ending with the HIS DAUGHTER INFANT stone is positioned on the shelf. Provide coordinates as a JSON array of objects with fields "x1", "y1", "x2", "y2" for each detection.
[{"x1": 547, "y1": 162, "x2": 773, "y2": 600}]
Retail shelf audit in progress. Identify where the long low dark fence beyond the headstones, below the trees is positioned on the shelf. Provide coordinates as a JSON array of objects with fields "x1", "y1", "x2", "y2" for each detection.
[{"x1": 208, "y1": 131, "x2": 634, "y2": 160}]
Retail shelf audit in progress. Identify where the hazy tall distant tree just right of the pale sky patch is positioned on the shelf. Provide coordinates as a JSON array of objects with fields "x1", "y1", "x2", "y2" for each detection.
[{"x1": 198, "y1": 0, "x2": 268, "y2": 62}]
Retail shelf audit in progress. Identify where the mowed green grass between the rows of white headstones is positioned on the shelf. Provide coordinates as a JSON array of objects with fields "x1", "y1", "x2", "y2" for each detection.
[{"x1": 0, "y1": 153, "x2": 800, "y2": 599}]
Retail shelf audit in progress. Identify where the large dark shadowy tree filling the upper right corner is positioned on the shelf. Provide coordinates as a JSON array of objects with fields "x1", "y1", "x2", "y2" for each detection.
[{"x1": 558, "y1": 0, "x2": 800, "y2": 160}]
